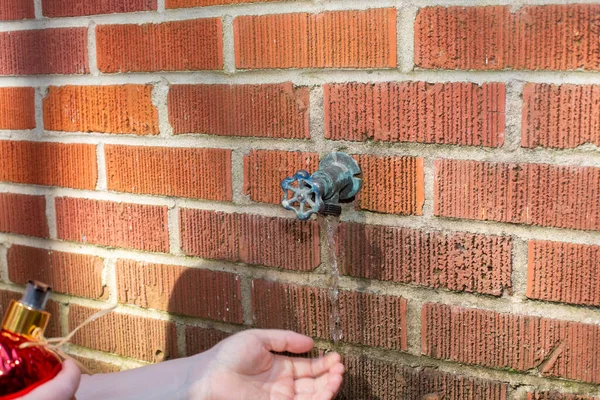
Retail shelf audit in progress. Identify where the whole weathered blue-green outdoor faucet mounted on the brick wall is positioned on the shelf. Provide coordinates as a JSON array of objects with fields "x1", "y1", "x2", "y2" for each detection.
[{"x1": 281, "y1": 152, "x2": 362, "y2": 221}]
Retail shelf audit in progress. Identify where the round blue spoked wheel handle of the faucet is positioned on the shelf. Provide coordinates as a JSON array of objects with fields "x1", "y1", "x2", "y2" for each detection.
[{"x1": 281, "y1": 170, "x2": 324, "y2": 221}]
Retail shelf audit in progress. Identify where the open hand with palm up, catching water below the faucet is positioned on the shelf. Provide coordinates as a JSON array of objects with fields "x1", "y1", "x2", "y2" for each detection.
[{"x1": 188, "y1": 330, "x2": 344, "y2": 400}]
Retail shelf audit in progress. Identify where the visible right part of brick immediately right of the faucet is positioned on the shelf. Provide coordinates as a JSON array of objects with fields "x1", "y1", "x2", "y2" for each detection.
[{"x1": 354, "y1": 154, "x2": 425, "y2": 215}]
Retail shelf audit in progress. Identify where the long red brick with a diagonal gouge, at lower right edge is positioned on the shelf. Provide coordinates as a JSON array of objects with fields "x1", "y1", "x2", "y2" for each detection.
[{"x1": 421, "y1": 303, "x2": 600, "y2": 383}]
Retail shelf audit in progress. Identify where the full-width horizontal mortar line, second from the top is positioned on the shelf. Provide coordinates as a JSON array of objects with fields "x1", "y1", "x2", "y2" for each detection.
[{"x1": 0, "y1": 67, "x2": 600, "y2": 87}]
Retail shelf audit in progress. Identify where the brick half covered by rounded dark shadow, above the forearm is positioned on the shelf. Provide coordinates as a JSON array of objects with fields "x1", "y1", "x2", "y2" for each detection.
[{"x1": 117, "y1": 260, "x2": 242, "y2": 324}]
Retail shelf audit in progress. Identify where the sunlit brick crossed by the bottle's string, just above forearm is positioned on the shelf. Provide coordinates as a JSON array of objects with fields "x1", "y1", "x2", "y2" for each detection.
[{"x1": 69, "y1": 304, "x2": 177, "y2": 361}]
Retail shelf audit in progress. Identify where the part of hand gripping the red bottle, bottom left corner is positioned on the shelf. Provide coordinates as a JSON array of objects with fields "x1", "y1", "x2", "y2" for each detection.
[{"x1": 21, "y1": 359, "x2": 81, "y2": 400}]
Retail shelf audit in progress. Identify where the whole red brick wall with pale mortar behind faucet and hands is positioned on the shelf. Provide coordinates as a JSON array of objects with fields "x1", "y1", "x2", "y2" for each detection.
[{"x1": 0, "y1": 0, "x2": 600, "y2": 400}]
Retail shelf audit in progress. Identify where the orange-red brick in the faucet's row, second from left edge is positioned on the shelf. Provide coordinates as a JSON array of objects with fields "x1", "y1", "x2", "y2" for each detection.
[{"x1": 104, "y1": 145, "x2": 232, "y2": 201}]
